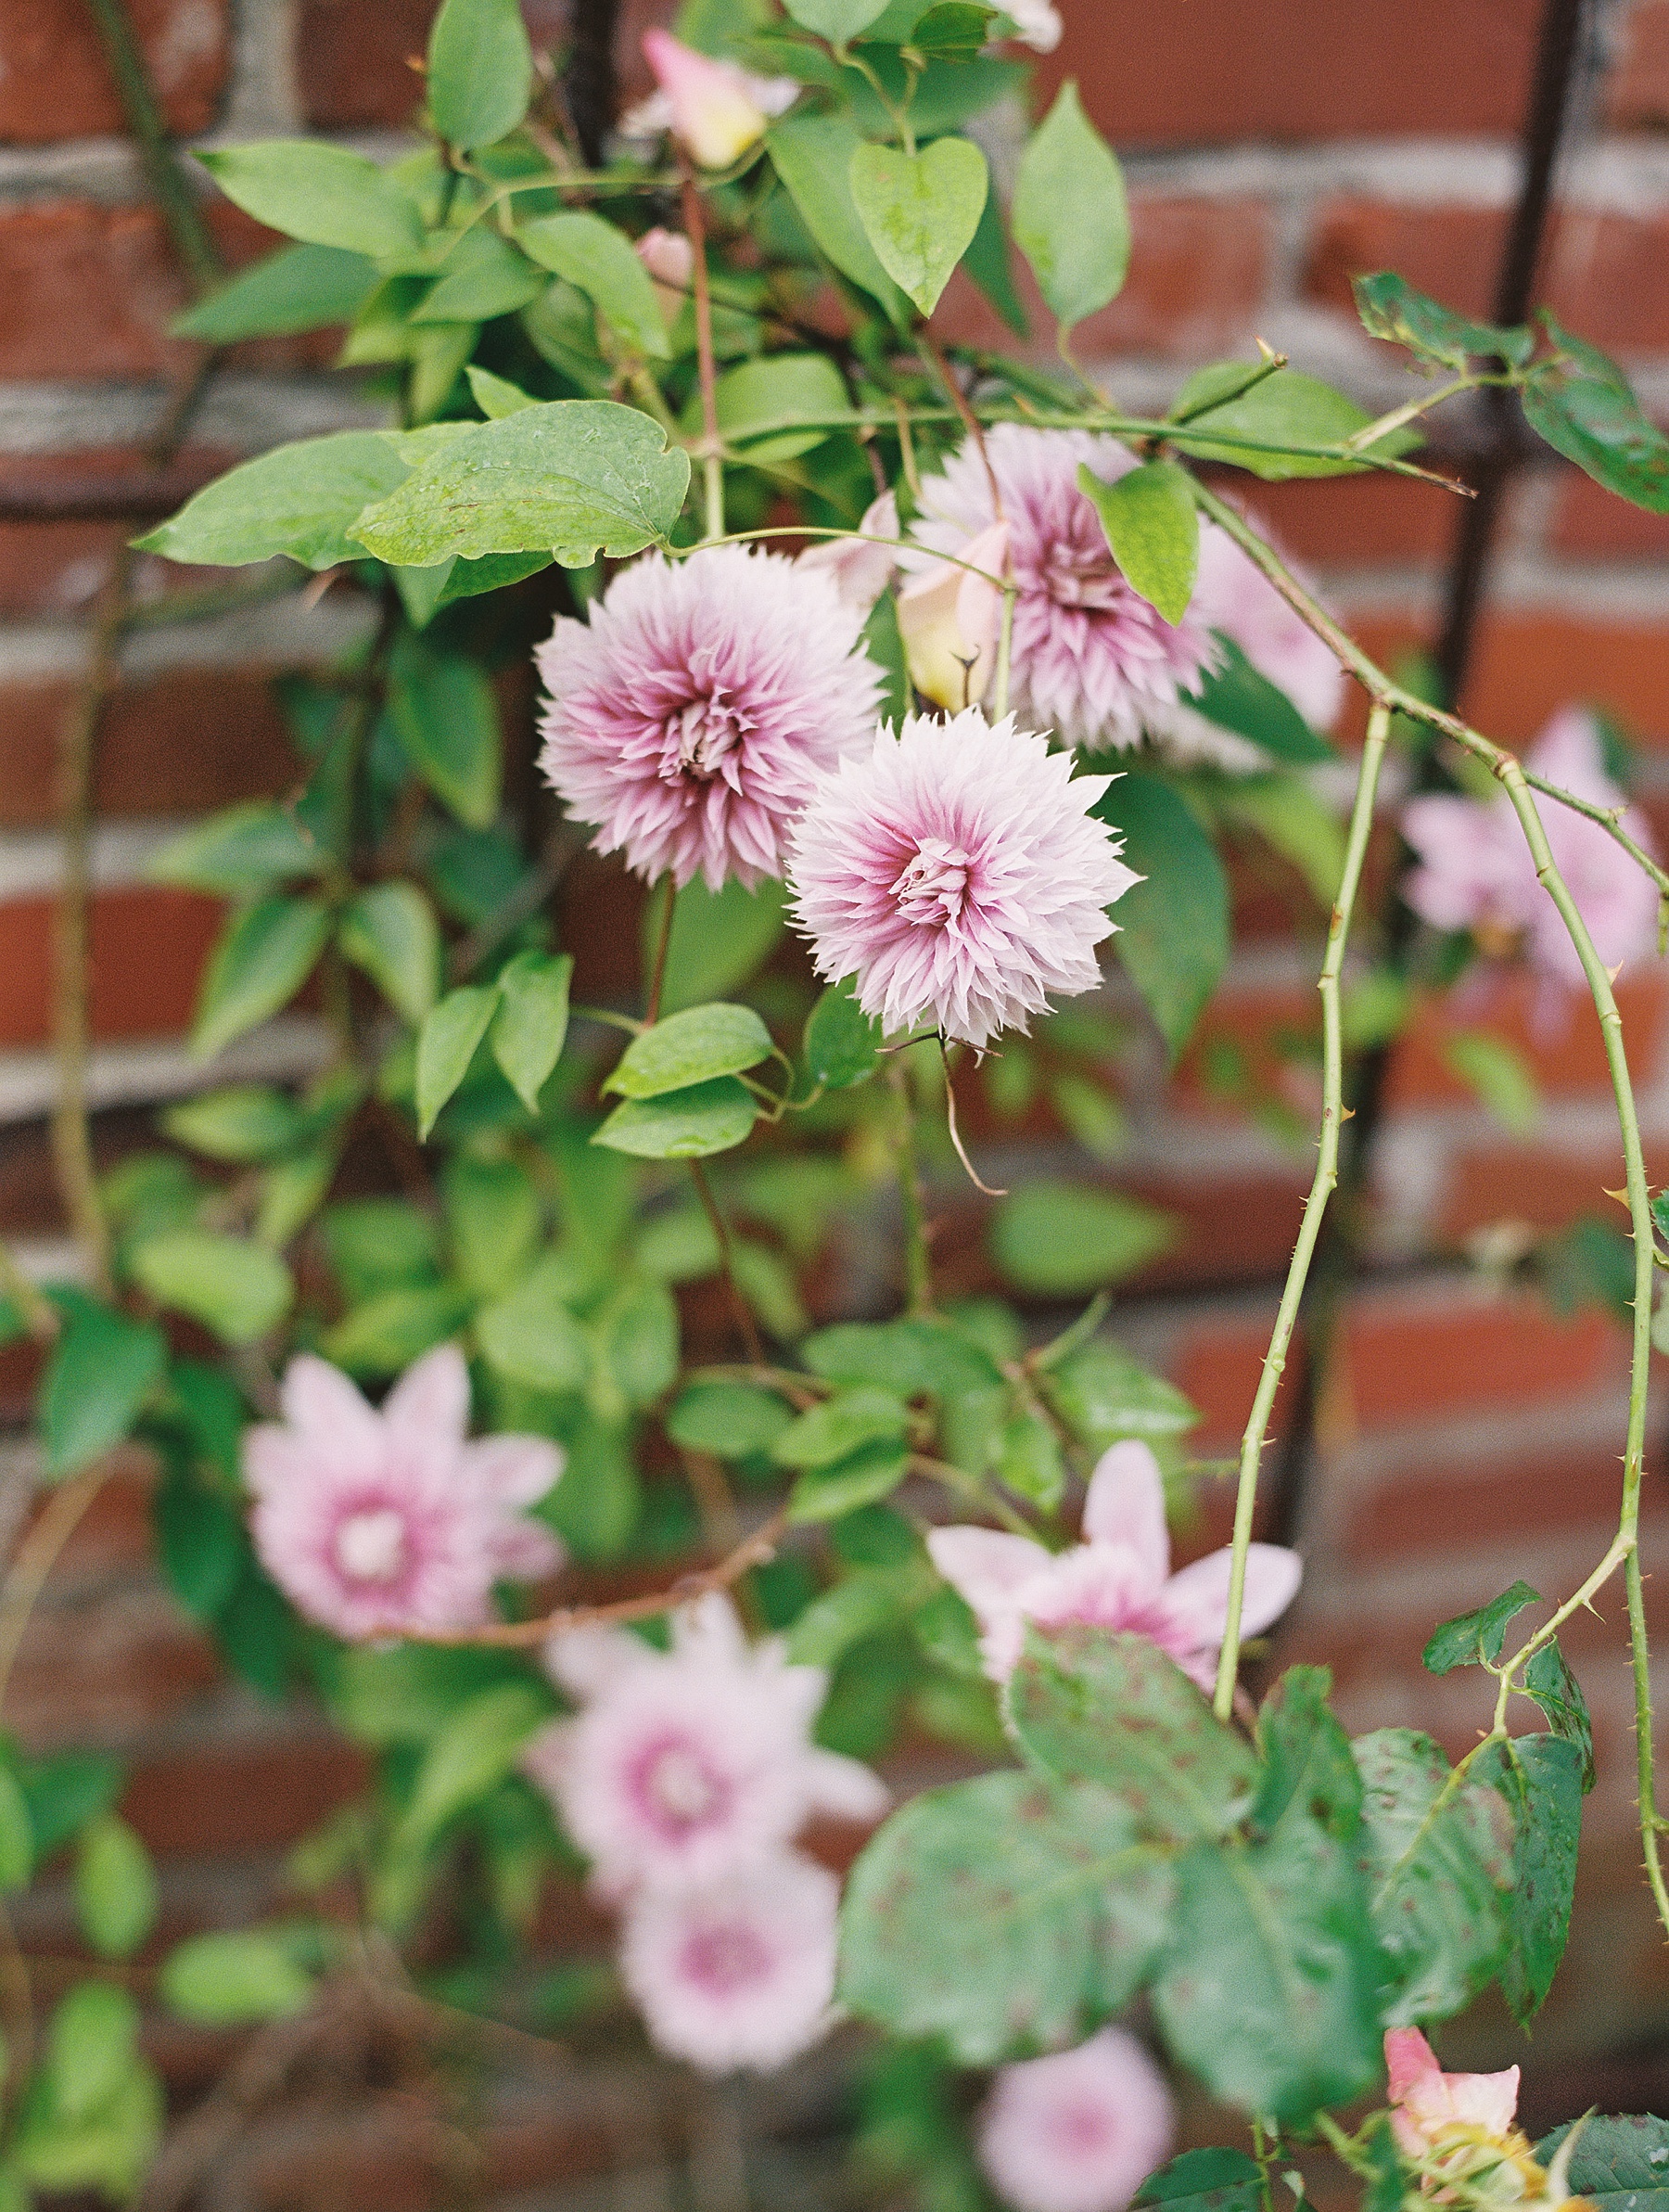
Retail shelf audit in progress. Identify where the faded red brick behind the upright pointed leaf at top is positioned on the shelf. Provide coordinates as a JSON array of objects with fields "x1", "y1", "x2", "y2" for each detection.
[{"x1": 935, "y1": 197, "x2": 1271, "y2": 361}]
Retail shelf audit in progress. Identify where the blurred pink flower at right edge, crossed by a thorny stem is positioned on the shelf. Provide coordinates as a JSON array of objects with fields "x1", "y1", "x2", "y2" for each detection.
[{"x1": 1402, "y1": 708, "x2": 1658, "y2": 989}]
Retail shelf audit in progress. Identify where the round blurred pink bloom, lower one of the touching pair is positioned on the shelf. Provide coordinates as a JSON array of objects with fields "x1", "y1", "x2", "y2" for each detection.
[{"x1": 621, "y1": 1851, "x2": 840, "y2": 2073}]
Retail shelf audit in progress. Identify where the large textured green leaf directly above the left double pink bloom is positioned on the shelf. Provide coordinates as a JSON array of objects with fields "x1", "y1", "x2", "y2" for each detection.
[{"x1": 353, "y1": 401, "x2": 690, "y2": 569}]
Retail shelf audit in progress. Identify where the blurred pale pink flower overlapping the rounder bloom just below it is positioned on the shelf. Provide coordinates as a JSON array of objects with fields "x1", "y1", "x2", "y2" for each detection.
[{"x1": 526, "y1": 1592, "x2": 886, "y2": 1896}]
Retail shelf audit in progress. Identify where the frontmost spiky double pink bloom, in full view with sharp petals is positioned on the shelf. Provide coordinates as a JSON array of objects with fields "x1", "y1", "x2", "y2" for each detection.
[{"x1": 789, "y1": 708, "x2": 1140, "y2": 1046}]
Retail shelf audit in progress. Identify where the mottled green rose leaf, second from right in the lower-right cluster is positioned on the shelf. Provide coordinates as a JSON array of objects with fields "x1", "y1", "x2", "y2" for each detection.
[{"x1": 1353, "y1": 1728, "x2": 1512, "y2": 2027}]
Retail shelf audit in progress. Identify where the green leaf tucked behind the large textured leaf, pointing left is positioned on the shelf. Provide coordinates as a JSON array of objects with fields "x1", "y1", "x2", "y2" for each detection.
[{"x1": 133, "y1": 429, "x2": 407, "y2": 570}]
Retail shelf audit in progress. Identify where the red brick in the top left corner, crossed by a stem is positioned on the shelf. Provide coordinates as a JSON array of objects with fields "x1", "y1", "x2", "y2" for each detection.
[{"x1": 0, "y1": 0, "x2": 232, "y2": 146}]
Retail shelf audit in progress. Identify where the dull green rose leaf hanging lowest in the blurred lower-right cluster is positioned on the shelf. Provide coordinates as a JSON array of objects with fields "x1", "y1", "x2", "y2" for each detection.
[{"x1": 1154, "y1": 1814, "x2": 1380, "y2": 2121}]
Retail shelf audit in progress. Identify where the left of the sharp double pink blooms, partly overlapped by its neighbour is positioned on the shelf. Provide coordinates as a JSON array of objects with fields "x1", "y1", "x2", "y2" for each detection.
[{"x1": 535, "y1": 546, "x2": 882, "y2": 891}]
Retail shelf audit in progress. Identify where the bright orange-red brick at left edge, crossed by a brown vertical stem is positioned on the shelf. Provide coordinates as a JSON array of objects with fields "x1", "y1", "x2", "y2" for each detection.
[{"x1": 0, "y1": 885, "x2": 221, "y2": 1046}]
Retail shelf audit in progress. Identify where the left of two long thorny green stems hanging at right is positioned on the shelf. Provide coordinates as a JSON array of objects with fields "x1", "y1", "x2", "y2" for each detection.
[{"x1": 1216, "y1": 701, "x2": 1391, "y2": 1721}]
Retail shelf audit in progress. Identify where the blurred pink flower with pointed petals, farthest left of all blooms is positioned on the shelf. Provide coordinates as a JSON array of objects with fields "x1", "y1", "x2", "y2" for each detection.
[{"x1": 243, "y1": 1345, "x2": 562, "y2": 1637}]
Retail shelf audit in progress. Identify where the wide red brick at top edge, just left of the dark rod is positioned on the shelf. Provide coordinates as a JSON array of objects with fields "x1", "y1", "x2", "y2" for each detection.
[{"x1": 1039, "y1": 0, "x2": 1541, "y2": 146}]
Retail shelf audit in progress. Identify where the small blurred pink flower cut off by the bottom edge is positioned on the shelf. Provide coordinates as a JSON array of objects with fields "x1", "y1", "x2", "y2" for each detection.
[{"x1": 979, "y1": 2028, "x2": 1176, "y2": 2212}]
